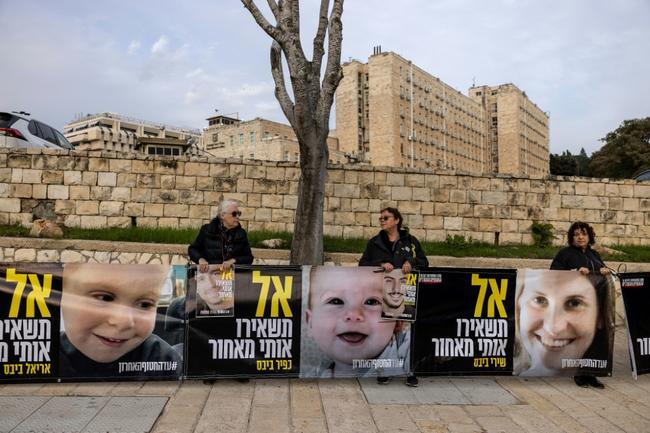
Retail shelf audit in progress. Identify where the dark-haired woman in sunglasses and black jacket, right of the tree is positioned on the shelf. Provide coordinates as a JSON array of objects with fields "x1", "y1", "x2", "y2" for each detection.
[{"x1": 359, "y1": 207, "x2": 429, "y2": 387}]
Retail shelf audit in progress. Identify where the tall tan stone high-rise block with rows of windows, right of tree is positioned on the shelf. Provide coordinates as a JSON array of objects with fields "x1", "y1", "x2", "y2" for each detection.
[{"x1": 336, "y1": 49, "x2": 548, "y2": 174}]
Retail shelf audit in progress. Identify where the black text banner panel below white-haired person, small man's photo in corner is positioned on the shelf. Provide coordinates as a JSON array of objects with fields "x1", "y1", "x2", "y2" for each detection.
[{"x1": 186, "y1": 265, "x2": 302, "y2": 378}]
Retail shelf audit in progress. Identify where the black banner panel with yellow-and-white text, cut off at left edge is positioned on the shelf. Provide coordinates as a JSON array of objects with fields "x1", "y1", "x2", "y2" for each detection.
[{"x1": 0, "y1": 263, "x2": 63, "y2": 382}]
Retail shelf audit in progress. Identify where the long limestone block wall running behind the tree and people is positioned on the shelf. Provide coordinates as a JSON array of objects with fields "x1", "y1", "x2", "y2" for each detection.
[{"x1": 0, "y1": 149, "x2": 650, "y2": 245}]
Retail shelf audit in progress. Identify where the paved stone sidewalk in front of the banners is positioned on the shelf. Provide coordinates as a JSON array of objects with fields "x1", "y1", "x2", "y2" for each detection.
[{"x1": 0, "y1": 327, "x2": 650, "y2": 433}]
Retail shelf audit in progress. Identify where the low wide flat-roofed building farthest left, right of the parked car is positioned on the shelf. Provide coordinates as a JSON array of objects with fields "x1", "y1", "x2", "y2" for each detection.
[{"x1": 63, "y1": 113, "x2": 203, "y2": 155}]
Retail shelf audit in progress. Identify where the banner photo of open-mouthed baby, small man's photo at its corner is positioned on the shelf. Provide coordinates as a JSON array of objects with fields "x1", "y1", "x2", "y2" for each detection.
[{"x1": 300, "y1": 266, "x2": 410, "y2": 378}]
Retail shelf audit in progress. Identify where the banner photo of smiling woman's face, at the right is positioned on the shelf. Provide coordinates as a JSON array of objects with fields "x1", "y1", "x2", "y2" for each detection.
[{"x1": 514, "y1": 269, "x2": 614, "y2": 376}]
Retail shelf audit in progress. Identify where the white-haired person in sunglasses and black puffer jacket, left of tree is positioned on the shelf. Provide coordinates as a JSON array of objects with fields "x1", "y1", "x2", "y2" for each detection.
[{"x1": 187, "y1": 200, "x2": 253, "y2": 272}]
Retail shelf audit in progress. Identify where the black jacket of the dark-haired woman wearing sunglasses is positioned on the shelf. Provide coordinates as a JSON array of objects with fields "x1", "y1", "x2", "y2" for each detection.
[{"x1": 359, "y1": 229, "x2": 429, "y2": 268}]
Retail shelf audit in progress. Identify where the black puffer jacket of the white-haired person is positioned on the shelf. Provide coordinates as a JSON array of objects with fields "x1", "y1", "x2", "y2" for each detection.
[{"x1": 187, "y1": 217, "x2": 253, "y2": 265}]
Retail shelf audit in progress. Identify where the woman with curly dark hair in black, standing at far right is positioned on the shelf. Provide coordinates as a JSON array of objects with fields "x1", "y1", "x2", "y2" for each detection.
[{"x1": 551, "y1": 221, "x2": 610, "y2": 389}]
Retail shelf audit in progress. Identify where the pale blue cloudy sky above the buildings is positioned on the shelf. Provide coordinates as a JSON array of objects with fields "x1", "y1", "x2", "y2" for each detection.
[{"x1": 0, "y1": 0, "x2": 650, "y2": 153}]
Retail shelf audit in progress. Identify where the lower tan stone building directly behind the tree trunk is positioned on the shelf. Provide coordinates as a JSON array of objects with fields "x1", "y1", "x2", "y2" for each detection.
[{"x1": 203, "y1": 115, "x2": 347, "y2": 163}]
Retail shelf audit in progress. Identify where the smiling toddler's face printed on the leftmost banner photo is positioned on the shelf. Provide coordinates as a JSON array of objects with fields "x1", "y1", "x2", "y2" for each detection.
[{"x1": 61, "y1": 263, "x2": 169, "y2": 363}]
